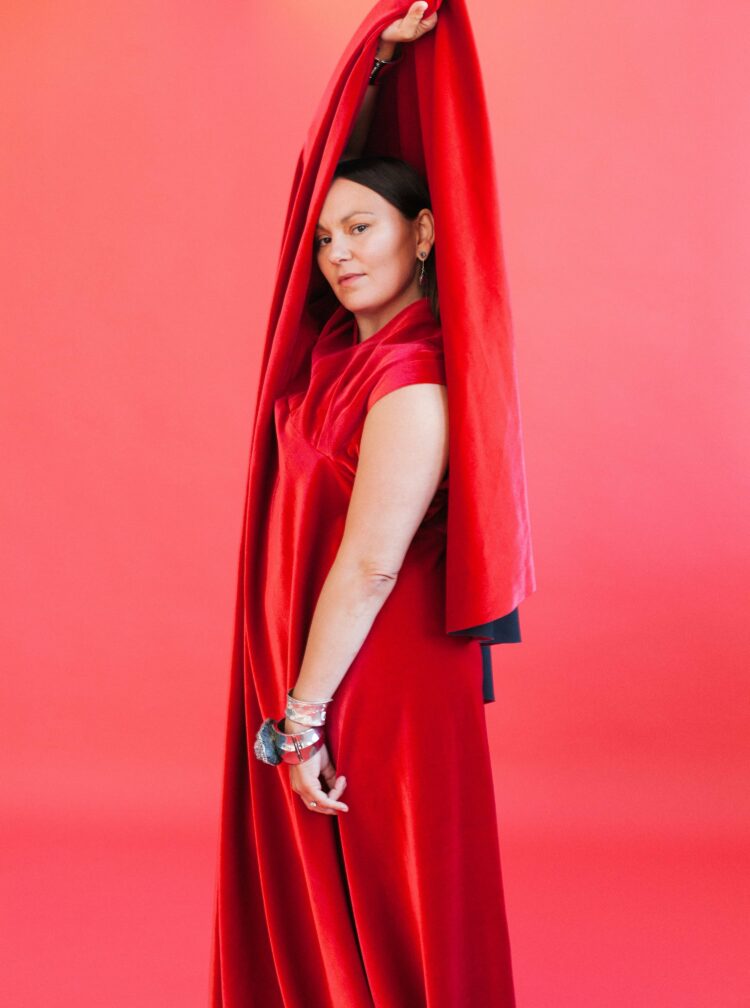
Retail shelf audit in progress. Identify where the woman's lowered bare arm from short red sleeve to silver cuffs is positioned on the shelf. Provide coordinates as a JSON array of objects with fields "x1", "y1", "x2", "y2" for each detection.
[{"x1": 285, "y1": 382, "x2": 448, "y2": 732}]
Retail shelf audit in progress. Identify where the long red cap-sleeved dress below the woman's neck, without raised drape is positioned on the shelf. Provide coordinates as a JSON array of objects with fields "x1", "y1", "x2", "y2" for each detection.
[{"x1": 212, "y1": 297, "x2": 515, "y2": 1008}]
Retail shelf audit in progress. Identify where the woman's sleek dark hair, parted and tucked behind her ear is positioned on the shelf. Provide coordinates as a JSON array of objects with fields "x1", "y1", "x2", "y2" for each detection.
[{"x1": 332, "y1": 154, "x2": 441, "y2": 322}]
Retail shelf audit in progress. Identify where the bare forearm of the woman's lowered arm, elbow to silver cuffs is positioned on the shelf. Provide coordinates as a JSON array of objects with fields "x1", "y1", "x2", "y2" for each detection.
[{"x1": 287, "y1": 558, "x2": 396, "y2": 731}]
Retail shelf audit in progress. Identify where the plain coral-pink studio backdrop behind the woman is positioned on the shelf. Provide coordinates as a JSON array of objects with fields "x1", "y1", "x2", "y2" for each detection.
[{"x1": 0, "y1": 0, "x2": 750, "y2": 1008}]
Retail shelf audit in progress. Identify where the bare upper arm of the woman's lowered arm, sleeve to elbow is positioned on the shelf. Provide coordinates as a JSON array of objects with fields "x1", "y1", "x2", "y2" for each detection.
[{"x1": 339, "y1": 382, "x2": 449, "y2": 577}]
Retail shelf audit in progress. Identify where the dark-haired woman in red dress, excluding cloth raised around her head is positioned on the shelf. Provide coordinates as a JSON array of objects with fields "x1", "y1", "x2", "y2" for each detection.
[{"x1": 212, "y1": 2, "x2": 529, "y2": 1008}]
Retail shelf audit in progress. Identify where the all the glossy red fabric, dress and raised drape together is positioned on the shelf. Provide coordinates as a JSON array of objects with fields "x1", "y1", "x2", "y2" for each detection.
[{"x1": 211, "y1": 0, "x2": 535, "y2": 1008}]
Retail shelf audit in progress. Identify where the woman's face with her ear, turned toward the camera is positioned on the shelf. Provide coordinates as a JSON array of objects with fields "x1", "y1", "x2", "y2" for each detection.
[{"x1": 315, "y1": 178, "x2": 433, "y2": 312}]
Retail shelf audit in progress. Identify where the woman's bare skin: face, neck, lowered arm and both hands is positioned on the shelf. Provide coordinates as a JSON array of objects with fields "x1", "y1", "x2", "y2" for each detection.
[{"x1": 281, "y1": 2, "x2": 441, "y2": 815}]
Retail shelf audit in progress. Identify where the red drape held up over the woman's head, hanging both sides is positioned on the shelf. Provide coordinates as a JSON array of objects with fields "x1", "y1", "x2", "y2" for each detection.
[{"x1": 237, "y1": 0, "x2": 535, "y2": 714}]
